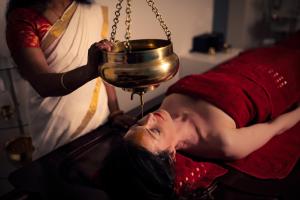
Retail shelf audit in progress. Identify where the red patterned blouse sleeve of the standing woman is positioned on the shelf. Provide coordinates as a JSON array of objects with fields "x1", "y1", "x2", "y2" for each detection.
[{"x1": 6, "y1": 8, "x2": 52, "y2": 51}]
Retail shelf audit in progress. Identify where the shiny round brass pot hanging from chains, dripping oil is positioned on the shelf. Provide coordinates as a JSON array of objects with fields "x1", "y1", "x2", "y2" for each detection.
[{"x1": 99, "y1": 39, "x2": 179, "y2": 93}]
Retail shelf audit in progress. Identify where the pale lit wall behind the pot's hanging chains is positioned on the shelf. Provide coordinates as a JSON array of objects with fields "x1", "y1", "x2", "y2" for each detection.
[{"x1": 97, "y1": 0, "x2": 213, "y2": 55}]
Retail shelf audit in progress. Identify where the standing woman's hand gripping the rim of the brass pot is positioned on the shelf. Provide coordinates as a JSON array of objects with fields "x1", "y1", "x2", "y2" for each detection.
[{"x1": 87, "y1": 39, "x2": 113, "y2": 77}]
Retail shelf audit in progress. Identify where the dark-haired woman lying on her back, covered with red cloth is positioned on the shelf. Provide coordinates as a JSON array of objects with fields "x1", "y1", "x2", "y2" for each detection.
[{"x1": 96, "y1": 38, "x2": 300, "y2": 200}]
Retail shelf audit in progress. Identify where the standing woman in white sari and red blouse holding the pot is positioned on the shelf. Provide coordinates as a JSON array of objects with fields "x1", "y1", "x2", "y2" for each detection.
[{"x1": 6, "y1": 0, "x2": 134, "y2": 159}]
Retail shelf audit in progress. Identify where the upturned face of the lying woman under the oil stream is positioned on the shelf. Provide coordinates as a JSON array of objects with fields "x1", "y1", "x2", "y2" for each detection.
[{"x1": 124, "y1": 109, "x2": 176, "y2": 154}]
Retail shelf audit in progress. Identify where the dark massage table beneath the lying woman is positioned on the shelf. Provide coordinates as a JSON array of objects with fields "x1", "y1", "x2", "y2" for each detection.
[{"x1": 1, "y1": 96, "x2": 300, "y2": 200}]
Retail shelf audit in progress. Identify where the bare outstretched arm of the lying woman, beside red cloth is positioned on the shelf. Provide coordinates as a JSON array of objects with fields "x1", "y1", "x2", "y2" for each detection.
[{"x1": 222, "y1": 107, "x2": 300, "y2": 159}]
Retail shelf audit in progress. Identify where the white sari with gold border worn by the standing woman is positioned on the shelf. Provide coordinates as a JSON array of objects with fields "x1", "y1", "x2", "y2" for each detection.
[{"x1": 28, "y1": 2, "x2": 109, "y2": 159}]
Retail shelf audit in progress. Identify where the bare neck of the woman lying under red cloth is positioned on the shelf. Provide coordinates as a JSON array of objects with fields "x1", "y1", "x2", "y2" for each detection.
[{"x1": 172, "y1": 112, "x2": 199, "y2": 150}]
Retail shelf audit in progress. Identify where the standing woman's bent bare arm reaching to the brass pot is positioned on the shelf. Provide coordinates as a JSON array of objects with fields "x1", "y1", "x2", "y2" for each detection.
[{"x1": 11, "y1": 43, "x2": 111, "y2": 97}]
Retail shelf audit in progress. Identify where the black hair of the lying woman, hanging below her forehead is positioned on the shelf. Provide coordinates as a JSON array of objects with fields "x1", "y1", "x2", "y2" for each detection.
[{"x1": 98, "y1": 141, "x2": 177, "y2": 200}]
